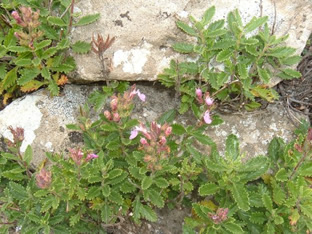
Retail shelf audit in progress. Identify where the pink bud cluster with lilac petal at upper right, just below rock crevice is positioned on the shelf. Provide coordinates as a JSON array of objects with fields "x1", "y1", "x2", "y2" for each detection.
[{"x1": 104, "y1": 85, "x2": 145, "y2": 123}]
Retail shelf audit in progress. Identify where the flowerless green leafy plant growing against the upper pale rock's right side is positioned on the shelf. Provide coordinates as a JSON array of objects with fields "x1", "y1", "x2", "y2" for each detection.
[{"x1": 158, "y1": 7, "x2": 301, "y2": 113}]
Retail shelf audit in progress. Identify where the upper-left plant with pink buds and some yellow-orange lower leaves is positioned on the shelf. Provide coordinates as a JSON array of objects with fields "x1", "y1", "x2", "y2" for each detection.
[{"x1": 0, "y1": 0, "x2": 99, "y2": 104}]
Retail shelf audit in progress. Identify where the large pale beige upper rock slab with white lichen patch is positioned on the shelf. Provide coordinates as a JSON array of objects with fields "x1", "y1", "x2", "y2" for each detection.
[{"x1": 72, "y1": 0, "x2": 312, "y2": 82}]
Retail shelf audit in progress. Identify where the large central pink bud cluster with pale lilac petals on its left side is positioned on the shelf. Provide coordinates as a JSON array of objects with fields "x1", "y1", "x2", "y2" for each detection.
[{"x1": 130, "y1": 121, "x2": 172, "y2": 171}]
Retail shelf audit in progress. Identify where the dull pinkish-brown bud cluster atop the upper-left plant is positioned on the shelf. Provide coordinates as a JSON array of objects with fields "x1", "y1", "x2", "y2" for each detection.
[{"x1": 11, "y1": 7, "x2": 43, "y2": 49}]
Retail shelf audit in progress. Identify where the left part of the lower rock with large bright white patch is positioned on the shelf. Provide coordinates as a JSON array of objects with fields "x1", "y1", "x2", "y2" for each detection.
[{"x1": 0, "y1": 85, "x2": 98, "y2": 166}]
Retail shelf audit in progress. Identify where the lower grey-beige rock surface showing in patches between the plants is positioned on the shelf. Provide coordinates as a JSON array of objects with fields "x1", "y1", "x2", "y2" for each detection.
[{"x1": 0, "y1": 82, "x2": 304, "y2": 165}]
